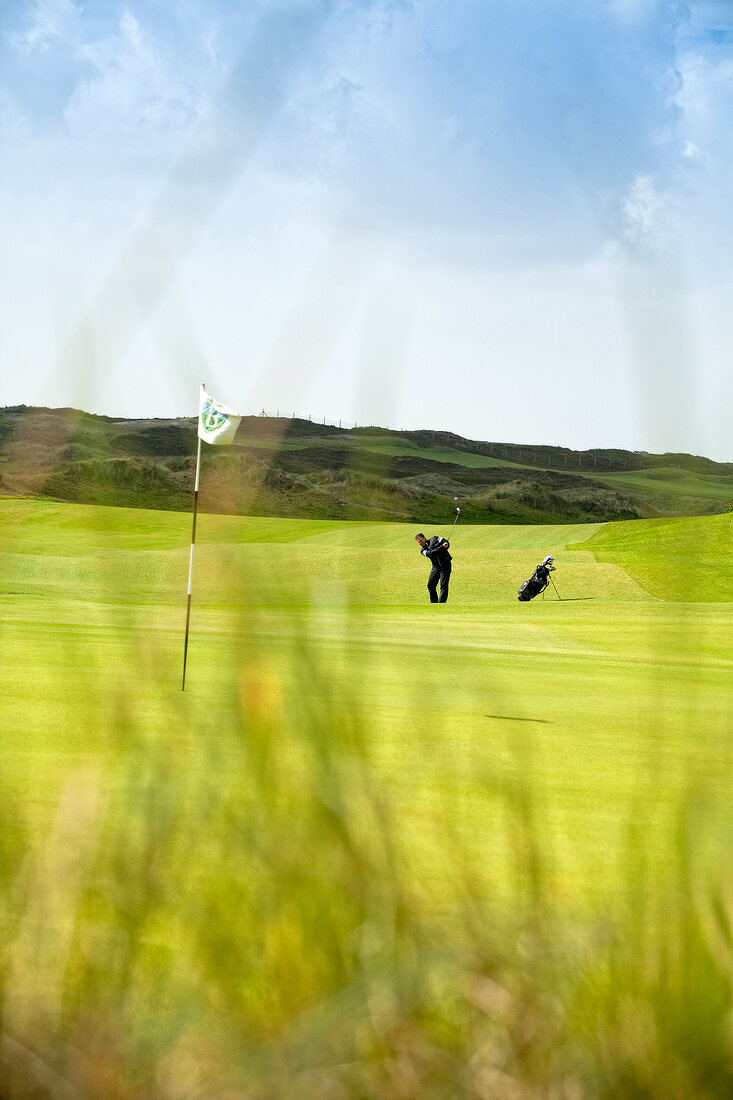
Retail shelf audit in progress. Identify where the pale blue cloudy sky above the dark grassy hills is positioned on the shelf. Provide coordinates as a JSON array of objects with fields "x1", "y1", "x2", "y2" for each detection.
[{"x1": 0, "y1": 0, "x2": 733, "y2": 461}]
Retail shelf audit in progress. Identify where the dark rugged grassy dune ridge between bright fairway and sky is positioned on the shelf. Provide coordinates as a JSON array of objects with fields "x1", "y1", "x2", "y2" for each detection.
[{"x1": 0, "y1": 406, "x2": 733, "y2": 525}]
